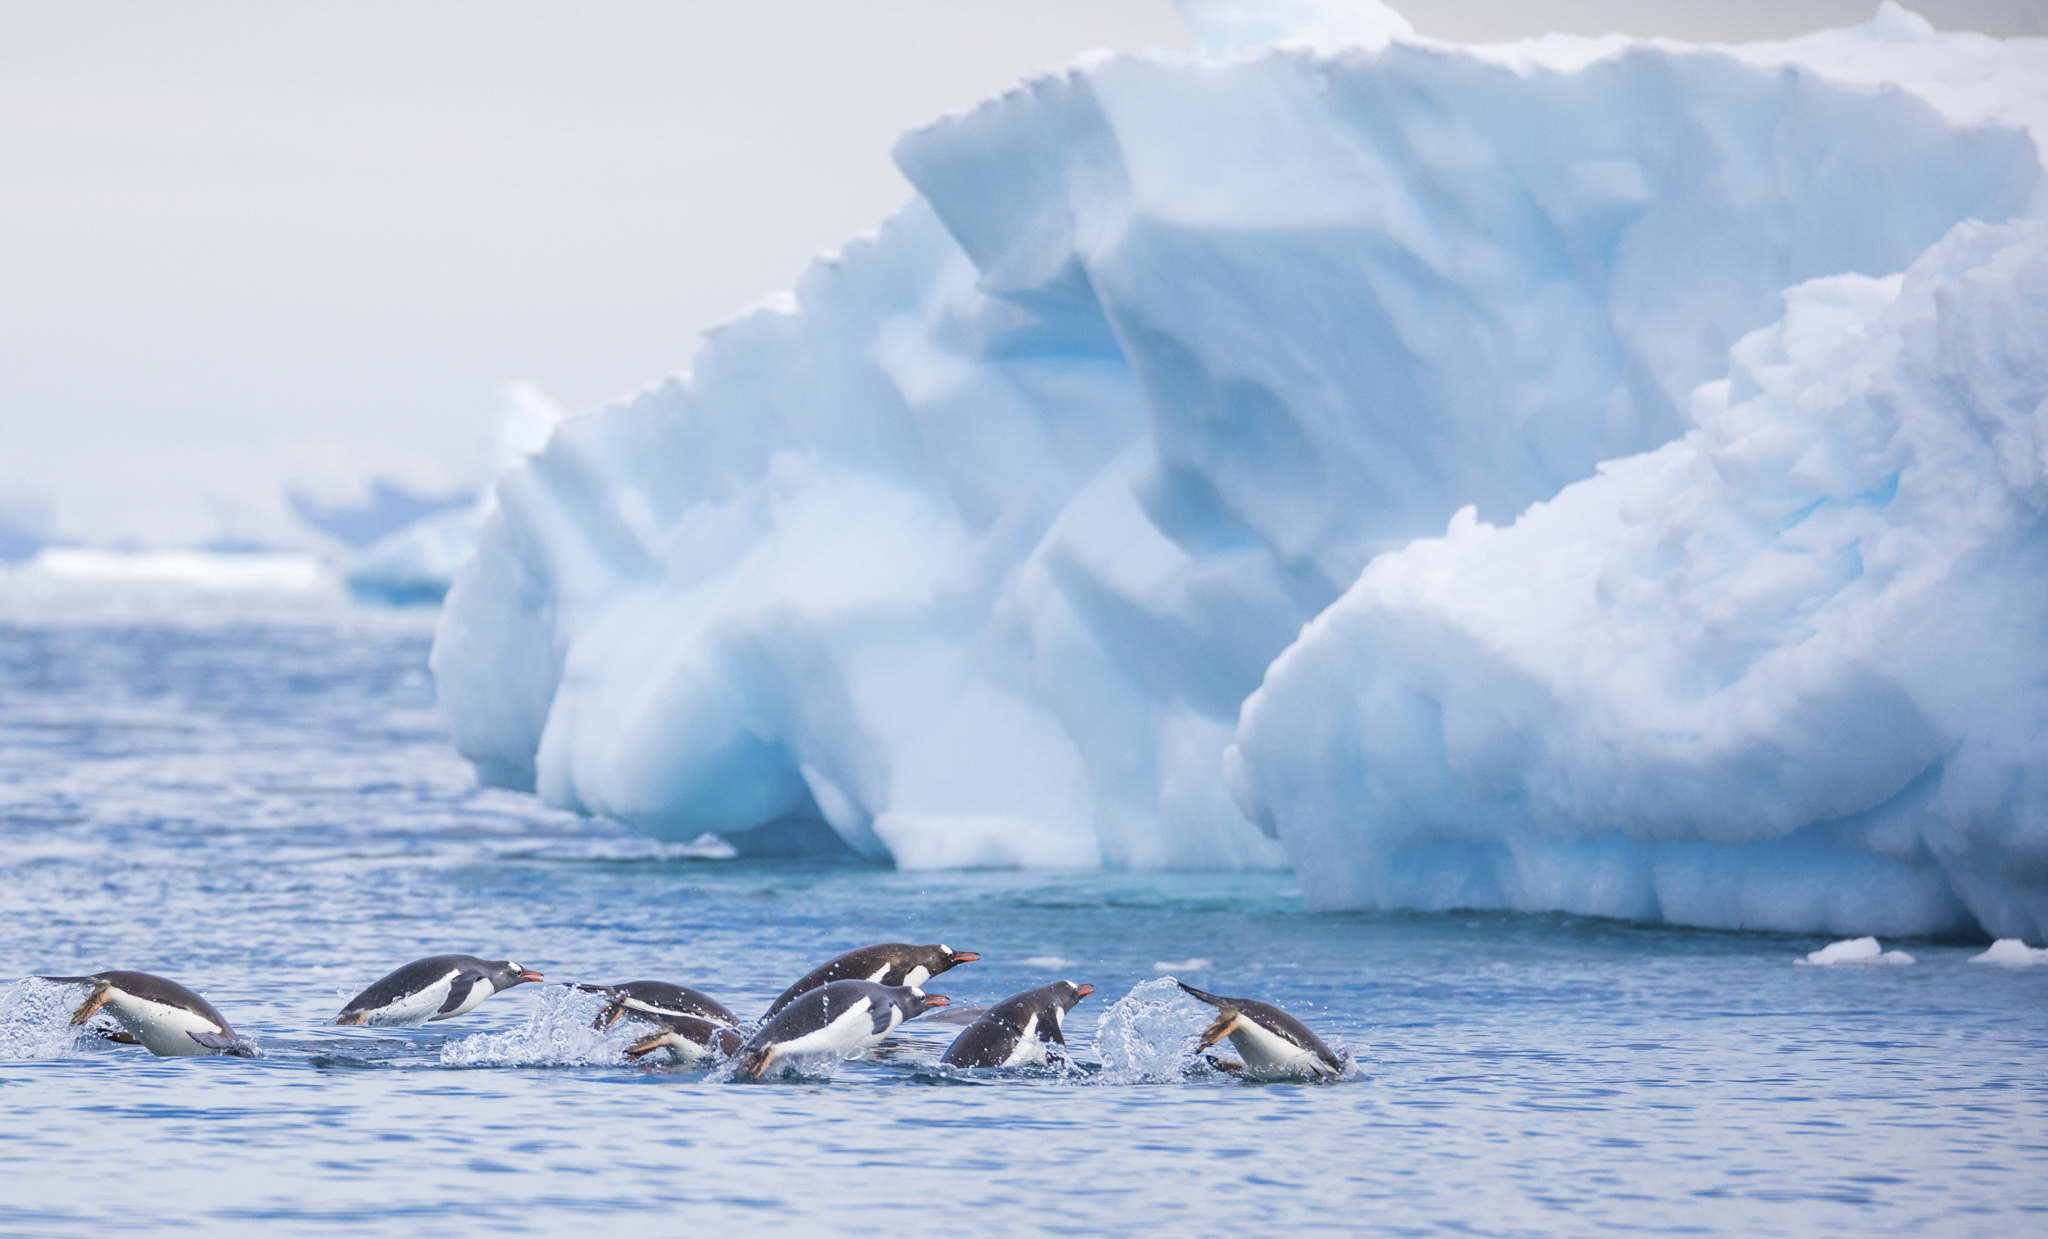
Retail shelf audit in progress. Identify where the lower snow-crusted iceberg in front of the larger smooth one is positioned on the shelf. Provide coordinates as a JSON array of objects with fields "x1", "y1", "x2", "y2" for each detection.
[{"x1": 1233, "y1": 221, "x2": 2048, "y2": 938}]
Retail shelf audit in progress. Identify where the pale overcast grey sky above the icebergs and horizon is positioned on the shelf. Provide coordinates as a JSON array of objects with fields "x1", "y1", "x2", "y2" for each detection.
[{"x1": 0, "y1": 0, "x2": 2048, "y2": 547}]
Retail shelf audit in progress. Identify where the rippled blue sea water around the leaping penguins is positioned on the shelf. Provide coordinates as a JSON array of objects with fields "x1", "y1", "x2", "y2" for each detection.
[{"x1": 0, "y1": 578, "x2": 2048, "y2": 1235}]
